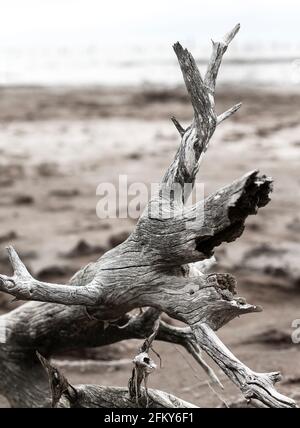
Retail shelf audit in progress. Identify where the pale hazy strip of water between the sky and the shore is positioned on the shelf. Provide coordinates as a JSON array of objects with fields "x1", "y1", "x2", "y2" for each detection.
[{"x1": 0, "y1": 42, "x2": 300, "y2": 87}]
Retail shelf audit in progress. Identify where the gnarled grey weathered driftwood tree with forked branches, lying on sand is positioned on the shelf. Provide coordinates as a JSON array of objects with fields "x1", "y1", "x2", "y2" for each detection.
[{"x1": 0, "y1": 25, "x2": 295, "y2": 407}]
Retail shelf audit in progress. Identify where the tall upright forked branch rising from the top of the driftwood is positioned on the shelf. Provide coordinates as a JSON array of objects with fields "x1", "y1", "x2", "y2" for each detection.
[{"x1": 162, "y1": 24, "x2": 240, "y2": 196}]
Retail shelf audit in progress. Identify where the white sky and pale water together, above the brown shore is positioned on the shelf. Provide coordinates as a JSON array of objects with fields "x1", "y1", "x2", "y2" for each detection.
[{"x1": 0, "y1": 0, "x2": 300, "y2": 87}]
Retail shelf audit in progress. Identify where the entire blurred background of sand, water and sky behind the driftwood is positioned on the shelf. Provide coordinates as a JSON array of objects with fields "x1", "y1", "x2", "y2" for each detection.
[{"x1": 0, "y1": 0, "x2": 300, "y2": 406}]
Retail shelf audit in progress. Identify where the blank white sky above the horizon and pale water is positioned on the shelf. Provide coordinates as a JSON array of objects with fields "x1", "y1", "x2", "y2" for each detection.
[{"x1": 0, "y1": 0, "x2": 300, "y2": 45}]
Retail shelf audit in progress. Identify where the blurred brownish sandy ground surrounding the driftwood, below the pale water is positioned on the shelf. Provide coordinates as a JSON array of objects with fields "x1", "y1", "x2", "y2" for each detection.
[{"x1": 0, "y1": 87, "x2": 300, "y2": 406}]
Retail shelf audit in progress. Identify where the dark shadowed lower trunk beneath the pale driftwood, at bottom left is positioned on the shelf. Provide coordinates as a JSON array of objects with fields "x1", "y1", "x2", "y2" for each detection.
[{"x1": 0, "y1": 302, "x2": 217, "y2": 407}]
